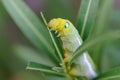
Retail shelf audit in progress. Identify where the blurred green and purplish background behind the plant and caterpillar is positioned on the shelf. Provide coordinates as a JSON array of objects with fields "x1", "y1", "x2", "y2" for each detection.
[{"x1": 0, "y1": 0, "x2": 120, "y2": 80}]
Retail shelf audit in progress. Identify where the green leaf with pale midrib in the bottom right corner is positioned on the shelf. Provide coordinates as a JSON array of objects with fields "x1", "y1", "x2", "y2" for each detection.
[{"x1": 96, "y1": 67, "x2": 120, "y2": 80}]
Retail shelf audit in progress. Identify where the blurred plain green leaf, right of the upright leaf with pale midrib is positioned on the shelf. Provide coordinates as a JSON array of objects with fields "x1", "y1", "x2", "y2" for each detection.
[{"x1": 90, "y1": 0, "x2": 113, "y2": 36}]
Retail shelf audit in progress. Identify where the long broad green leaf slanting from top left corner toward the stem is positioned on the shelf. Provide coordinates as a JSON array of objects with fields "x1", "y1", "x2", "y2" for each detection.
[{"x1": 2, "y1": 0, "x2": 59, "y2": 60}]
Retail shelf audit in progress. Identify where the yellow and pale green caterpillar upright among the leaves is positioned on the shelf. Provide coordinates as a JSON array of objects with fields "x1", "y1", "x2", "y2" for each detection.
[{"x1": 48, "y1": 18, "x2": 97, "y2": 79}]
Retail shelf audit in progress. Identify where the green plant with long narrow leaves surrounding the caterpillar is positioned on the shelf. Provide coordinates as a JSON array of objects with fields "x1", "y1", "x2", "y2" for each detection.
[{"x1": 2, "y1": 0, "x2": 120, "y2": 80}]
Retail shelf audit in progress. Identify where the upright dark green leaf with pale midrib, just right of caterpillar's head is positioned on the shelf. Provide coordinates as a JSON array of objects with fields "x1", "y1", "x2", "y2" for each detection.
[{"x1": 77, "y1": 0, "x2": 100, "y2": 40}]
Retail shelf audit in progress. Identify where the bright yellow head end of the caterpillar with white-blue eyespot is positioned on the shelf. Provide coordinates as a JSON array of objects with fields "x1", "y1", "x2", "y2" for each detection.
[{"x1": 48, "y1": 18, "x2": 72, "y2": 36}]
